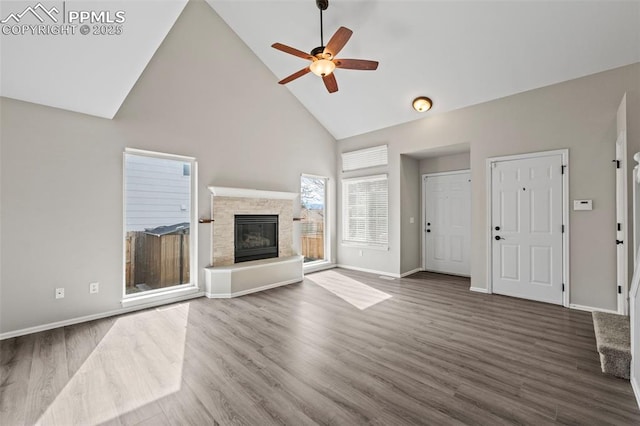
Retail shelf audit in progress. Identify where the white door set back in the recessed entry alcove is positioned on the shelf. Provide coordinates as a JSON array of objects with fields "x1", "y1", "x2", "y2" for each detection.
[{"x1": 423, "y1": 171, "x2": 471, "y2": 276}]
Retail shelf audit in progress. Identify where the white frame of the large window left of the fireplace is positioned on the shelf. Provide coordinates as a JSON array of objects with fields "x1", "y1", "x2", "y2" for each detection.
[{"x1": 121, "y1": 148, "x2": 200, "y2": 307}]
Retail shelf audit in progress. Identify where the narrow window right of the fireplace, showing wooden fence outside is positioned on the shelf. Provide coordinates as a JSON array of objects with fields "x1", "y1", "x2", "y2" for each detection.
[{"x1": 300, "y1": 175, "x2": 328, "y2": 263}]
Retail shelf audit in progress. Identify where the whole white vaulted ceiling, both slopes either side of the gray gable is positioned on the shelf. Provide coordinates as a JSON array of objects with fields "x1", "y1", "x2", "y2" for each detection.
[{"x1": 0, "y1": 0, "x2": 640, "y2": 139}]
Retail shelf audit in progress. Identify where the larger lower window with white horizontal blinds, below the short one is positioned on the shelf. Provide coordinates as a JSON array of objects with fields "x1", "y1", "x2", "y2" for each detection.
[{"x1": 342, "y1": 175, "x2": 389, "y2": 248}]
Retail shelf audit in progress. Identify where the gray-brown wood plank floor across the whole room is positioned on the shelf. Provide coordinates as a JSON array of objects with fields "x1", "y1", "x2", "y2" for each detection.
[{"x1": 0, "y1": 270, "x2": 640, "y2": 426}]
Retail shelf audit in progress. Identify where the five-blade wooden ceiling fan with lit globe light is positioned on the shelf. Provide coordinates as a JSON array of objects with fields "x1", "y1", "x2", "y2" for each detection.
[{"x1": 271, "y1": 0, "x2": 378, "y2": 93}]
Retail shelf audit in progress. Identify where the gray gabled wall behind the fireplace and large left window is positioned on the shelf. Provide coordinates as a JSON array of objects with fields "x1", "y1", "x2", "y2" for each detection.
[{"x1": 0, "y1": 2, "x2": 336, "y2": 332}]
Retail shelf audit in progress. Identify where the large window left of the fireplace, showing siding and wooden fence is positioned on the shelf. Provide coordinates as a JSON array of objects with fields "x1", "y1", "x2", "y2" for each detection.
[{"x1": 124, "y1": 150, "x2": 197, "y2": 296}]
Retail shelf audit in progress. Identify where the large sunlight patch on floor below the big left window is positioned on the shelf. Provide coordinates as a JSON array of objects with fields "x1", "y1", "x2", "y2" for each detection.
[{"x1": 38, "y1": 303, "x2": 189, "y2": 425}]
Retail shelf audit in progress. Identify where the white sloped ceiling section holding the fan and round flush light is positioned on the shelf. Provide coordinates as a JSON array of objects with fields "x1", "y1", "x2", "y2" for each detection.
[{"x1": 208, "y1": 0, "x2": 640, "y2": 139}]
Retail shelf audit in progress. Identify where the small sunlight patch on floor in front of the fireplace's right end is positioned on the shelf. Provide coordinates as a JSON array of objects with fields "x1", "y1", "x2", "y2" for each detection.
[{"x1": 305, "y1": 271, "x2": 392, "y2": 310}]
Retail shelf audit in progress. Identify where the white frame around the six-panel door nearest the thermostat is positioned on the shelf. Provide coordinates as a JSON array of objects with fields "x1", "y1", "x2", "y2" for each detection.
[{"x1": 485, "y1": 149, "x2": 571, "y2": 308}]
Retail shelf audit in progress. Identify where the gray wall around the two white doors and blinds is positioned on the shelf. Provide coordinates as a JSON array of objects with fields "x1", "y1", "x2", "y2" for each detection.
[{"x1": 338, "y1": 64, "x2": 640, "y2": 309}]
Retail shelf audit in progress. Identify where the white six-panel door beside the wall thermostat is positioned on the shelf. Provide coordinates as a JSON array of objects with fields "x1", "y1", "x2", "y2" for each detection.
[{"x1": 491, "y1": 154, "x2": 563, "y2": 304}]
